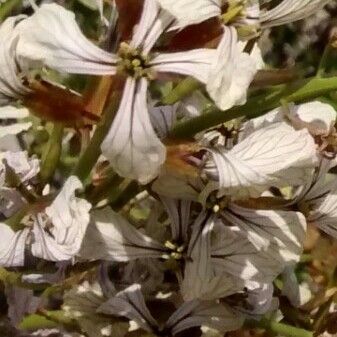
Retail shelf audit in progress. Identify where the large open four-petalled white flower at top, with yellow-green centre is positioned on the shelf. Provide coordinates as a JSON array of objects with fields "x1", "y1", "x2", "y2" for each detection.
[{"x1": 18, "y1": 0, "x2": 255, "y2": 183}]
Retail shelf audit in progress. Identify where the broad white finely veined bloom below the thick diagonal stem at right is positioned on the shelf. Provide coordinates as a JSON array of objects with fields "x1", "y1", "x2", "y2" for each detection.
[{"x1": 204, "y1": 123, "x2": 317, "y2": 198}]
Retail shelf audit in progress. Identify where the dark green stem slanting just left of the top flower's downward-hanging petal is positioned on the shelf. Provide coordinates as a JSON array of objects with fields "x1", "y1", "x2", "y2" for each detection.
[{"x1": 72, "y1": 94, "x2": 119, "y2": 182}]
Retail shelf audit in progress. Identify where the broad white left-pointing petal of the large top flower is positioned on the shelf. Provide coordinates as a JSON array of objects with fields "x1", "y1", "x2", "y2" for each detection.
[{"x1": 17, "y1": 4, "x2": 117, "y2": 75}]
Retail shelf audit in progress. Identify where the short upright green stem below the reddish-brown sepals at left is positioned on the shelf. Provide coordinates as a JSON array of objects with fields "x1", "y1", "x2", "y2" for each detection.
[{"x1": 40, "y1": 123, "x2": 64, "y2": 185}]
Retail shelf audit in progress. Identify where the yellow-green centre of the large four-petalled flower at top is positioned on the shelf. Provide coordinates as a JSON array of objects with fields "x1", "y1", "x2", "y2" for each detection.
[{"x1": 117, "y1": 42, "x2": 153, "y2": 80}]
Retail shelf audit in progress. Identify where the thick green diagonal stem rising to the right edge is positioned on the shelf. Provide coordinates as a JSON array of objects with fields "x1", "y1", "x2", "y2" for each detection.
[{"x1": 169, "y1": 77, "x2": 337, "y2": 139}]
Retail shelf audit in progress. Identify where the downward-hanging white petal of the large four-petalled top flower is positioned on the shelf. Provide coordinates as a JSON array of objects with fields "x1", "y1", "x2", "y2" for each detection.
[{"x1": 101, "y1": 78, "x2": 166, "y2": 184}]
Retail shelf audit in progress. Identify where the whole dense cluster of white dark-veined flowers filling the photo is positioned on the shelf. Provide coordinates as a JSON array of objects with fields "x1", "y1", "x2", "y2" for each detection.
[{"x1": 0, "y1": 0, "x2": 337, "y2": 337}]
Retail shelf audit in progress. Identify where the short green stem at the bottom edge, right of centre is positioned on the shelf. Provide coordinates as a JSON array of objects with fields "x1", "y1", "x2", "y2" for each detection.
[{"x1": 246, "y1": 318, "x2": 313, "y2": 337}]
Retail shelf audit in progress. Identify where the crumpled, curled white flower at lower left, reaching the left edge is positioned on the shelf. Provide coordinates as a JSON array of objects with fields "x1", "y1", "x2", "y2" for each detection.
[{"x1": 0, "y1": 176, "x2": 91, "y2": 266}]
